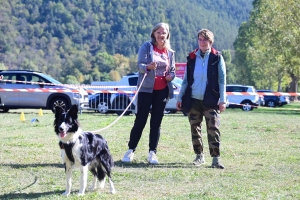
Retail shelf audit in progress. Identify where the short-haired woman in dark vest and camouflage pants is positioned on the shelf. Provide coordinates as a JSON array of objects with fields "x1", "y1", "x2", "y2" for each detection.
[{"x1": 176, "y1": 29, "x2": 226, "y2": 169}]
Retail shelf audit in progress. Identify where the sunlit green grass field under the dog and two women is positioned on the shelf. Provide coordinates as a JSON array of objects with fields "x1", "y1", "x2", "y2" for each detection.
[{"x1": 0, "y1": 103, "x2": 300, "y2": 200}]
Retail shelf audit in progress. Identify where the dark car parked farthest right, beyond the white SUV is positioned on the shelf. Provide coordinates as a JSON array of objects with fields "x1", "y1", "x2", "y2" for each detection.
[{"x1": 257, "y1": 90, "x2": 290, "y2": 107}]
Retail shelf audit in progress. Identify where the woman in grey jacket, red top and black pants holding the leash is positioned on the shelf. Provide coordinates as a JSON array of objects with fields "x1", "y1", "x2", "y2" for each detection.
[{"x1": 122, "y1": 23, "x2": 175, "y2": 164}]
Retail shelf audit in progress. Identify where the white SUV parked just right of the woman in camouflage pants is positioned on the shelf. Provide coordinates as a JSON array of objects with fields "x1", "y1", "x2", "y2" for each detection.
[{"x1": 226, "y1": 84, "x2": 265, "y2": 111}]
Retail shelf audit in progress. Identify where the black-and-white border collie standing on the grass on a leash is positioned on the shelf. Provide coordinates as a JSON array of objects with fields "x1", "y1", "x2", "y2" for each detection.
[{"x1": 54, "y1": 105, "x2": 116, "y2": 196}]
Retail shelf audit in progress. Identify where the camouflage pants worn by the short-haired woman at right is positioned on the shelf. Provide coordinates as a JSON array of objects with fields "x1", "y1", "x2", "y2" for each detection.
[{"x1": 188, "y1": 99, "x2": 221, "y2": 157}]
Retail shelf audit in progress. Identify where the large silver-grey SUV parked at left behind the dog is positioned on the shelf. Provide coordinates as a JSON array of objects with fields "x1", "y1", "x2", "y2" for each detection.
[{"x1": 0, "y1": 70, "x2": 88, "y2": 112}]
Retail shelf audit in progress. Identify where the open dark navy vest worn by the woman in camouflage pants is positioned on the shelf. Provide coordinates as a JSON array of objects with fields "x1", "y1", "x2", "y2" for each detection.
[{"x1": 182, "y1": 48, "x2": 220, "y2": 112}]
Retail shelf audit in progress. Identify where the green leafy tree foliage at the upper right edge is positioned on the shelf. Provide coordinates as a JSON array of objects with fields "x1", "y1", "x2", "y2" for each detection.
[{"x1": 234, "y1": 0, "x2": 300, "y2": 92}]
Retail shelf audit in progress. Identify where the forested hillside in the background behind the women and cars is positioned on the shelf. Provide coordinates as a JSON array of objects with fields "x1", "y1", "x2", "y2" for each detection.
[{"x1": 0, "y1": 0, "x2": 252, "y2": 84}]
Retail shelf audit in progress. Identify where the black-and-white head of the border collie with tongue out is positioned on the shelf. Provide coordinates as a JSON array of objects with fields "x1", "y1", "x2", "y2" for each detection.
[{"x1": 54, "y1": 105, "x2": 79, "y2": 138}]
